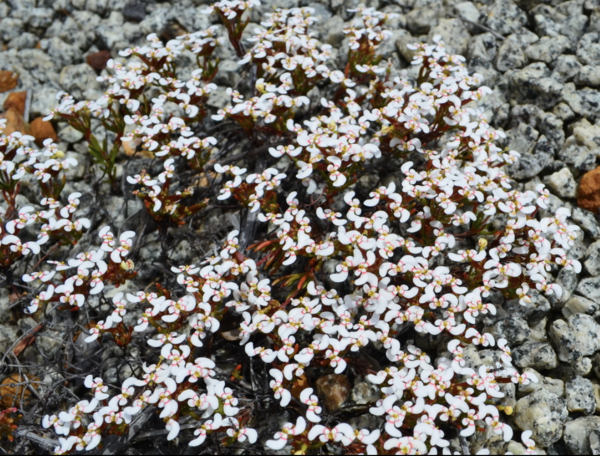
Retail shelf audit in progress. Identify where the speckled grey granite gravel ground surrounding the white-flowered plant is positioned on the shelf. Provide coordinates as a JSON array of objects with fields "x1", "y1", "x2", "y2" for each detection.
[{"x1": 0, "y1": 0, "x2": 600, "y2": 454}]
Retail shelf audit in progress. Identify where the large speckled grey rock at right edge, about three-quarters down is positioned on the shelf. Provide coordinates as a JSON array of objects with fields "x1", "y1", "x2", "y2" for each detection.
[{"x1": 549, "y1": 314, "x2": 600, "y2": 362}]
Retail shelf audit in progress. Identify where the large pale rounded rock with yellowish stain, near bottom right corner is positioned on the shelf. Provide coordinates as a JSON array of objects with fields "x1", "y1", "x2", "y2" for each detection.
[{"x1": 514, "y1": 388, "x2": 569, "y2": 447}]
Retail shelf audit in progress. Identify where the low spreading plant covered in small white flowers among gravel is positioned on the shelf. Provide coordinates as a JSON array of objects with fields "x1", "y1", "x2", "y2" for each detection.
[{"x1": 0, "y1": 0, "x2": 581, "y2": 454}]
